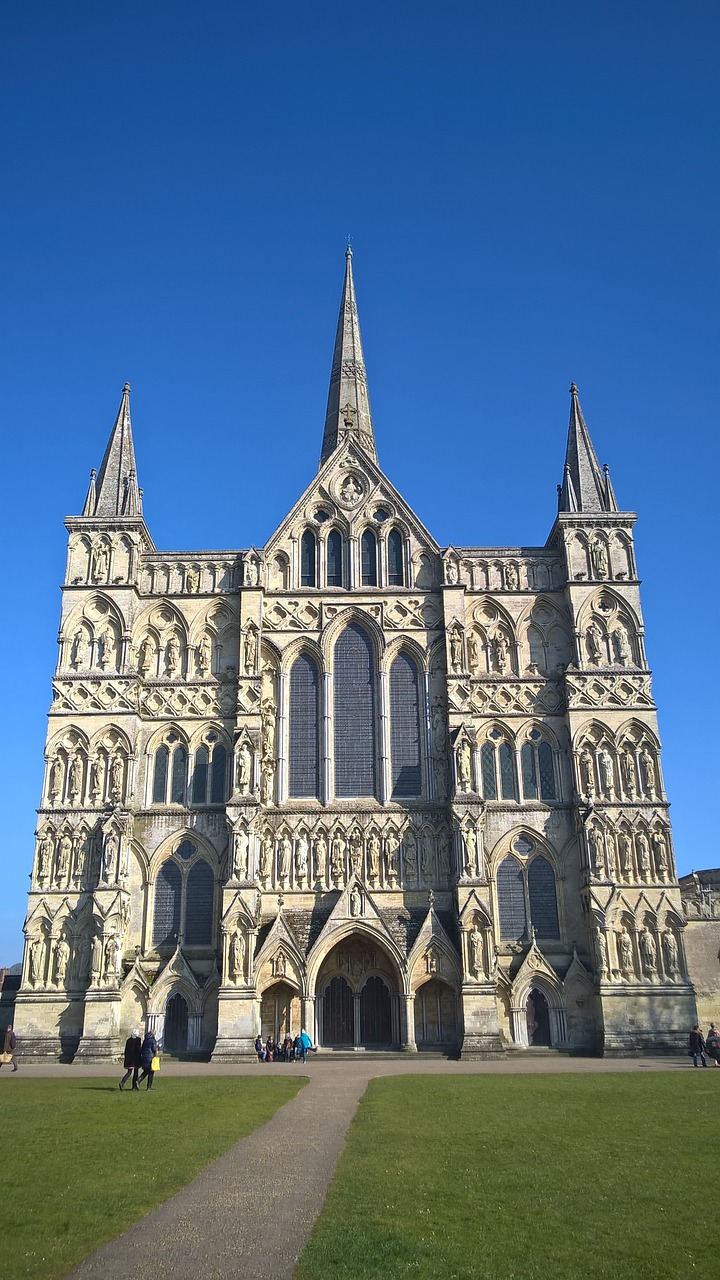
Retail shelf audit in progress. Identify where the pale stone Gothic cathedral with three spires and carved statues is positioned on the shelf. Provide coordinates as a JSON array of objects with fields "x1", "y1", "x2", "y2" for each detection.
[{"x1": 15, "y1": 250, "x2": 696, "y2": 1061}]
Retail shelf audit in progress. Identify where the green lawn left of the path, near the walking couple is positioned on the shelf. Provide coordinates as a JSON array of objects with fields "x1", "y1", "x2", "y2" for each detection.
[{"x1": 0, "y1": 1076, "x2": 305, "y2": 1280}]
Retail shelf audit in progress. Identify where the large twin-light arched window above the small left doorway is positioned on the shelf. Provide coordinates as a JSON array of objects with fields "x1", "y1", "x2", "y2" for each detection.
[{"x1": 152, "y1": 838, "x2": 215, "y2": 948}]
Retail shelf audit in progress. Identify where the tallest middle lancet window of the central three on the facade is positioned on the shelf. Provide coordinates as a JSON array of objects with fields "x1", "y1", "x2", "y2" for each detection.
[{"x1": 334, "y1": 622, "x2": 375, "y2": 799}]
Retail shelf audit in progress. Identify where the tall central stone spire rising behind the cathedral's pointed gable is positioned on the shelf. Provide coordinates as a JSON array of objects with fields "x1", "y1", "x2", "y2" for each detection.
[{"x1": 320, "y1": 244, "x2": 377, "y2": 466}]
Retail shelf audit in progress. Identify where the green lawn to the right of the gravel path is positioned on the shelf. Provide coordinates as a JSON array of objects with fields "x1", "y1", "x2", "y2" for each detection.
[{"x1": 295, "y1": 1070, "x2": 720, "y2": 1280}]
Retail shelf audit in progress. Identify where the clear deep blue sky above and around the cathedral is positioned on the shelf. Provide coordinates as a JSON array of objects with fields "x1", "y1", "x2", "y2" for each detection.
[{"x1": 0, "y1": 0, "x2": 720, "y2": 964}]
